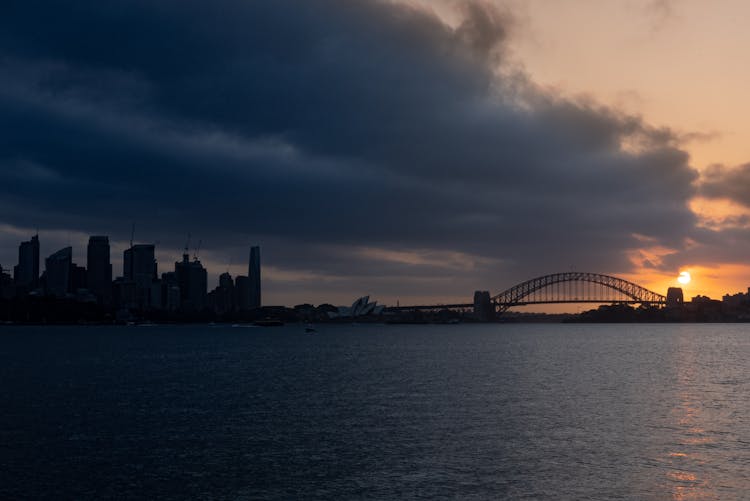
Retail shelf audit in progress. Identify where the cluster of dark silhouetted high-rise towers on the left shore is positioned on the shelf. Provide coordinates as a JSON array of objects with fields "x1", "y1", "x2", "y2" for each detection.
[{"x1": 0, "y1": 235, "x2": 261, "y2": 319}]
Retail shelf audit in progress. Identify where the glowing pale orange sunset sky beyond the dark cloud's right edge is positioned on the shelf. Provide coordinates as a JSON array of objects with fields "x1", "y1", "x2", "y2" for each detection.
[{"x1": 418, "y1": 0, "x2": 750, "y2": 304}]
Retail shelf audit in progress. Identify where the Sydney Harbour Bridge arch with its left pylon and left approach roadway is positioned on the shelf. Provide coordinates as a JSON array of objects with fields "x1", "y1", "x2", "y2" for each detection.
[{"x1": 392, "y1": 271, "x2": 667, "y2": 313}]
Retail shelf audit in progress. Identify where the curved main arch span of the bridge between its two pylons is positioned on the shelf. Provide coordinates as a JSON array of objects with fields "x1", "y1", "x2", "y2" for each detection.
[{"x1": 492, "y1": 271, "x2": 666, "y2": 313}]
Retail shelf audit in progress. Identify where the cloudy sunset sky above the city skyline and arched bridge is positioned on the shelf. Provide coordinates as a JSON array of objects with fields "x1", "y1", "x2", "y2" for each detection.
[{"x1": 0, "y1": 0, "x2": 750, "y2": 305}]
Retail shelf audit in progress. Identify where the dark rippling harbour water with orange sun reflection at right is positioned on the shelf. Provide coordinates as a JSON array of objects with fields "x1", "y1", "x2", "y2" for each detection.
[{"x1": 0, "y1": 325, "x2": 750, "y2": 500}]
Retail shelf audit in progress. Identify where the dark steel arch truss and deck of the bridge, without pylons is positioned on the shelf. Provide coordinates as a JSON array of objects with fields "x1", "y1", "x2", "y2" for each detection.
[{"x1": 492, "y1": 271, "x2": 666, "y2": 313}]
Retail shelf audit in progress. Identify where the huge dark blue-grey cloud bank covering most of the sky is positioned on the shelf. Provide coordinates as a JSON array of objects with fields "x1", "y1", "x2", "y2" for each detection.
[{"x1": 0, "y1": 0, "x2": 696, "y2": 295}]
